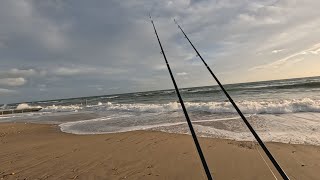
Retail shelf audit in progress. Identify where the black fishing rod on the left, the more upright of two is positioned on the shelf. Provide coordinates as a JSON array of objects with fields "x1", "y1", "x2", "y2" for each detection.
[{"x1": 150, "y1": 16, "x2": 213, "y2": 180}]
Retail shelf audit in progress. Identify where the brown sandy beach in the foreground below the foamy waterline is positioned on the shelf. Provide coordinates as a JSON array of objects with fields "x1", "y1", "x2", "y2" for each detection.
[{"x1": 0, "y1": 123, "x2": 320, "y2": 180}]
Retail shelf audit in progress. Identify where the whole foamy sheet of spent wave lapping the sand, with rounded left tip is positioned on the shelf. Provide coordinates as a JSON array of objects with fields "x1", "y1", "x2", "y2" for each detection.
[{"x1": 60, "y1": 113, "x2": 320, "y2": 145}]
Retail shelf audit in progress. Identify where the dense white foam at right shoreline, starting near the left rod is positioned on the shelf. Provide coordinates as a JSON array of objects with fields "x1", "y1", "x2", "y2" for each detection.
[{"x1": 168, "y1": 113, "x2": 320, "y2": 145}]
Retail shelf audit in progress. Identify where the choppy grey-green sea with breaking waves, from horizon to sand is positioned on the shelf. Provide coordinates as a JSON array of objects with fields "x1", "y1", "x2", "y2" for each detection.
[{"x1": 0, "y1": 77, "x2": 320, "y2": 145}]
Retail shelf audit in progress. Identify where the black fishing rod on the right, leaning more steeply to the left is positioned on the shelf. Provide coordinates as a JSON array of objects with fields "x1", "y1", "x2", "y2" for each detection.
[{"x1": 174, "y1": 19, "x2": 289, "y2": 180}]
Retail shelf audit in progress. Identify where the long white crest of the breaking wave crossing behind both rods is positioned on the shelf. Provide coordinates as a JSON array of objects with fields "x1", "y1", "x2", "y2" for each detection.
[{"x1": 92, "y1": 98, "x2": 320, "y2": 114}]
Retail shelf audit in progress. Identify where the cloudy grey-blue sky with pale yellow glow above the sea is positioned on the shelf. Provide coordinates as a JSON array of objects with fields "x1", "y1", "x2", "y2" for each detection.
[{"x1": 0, "y1": 0, "x2": 320, "y2": 103}]
